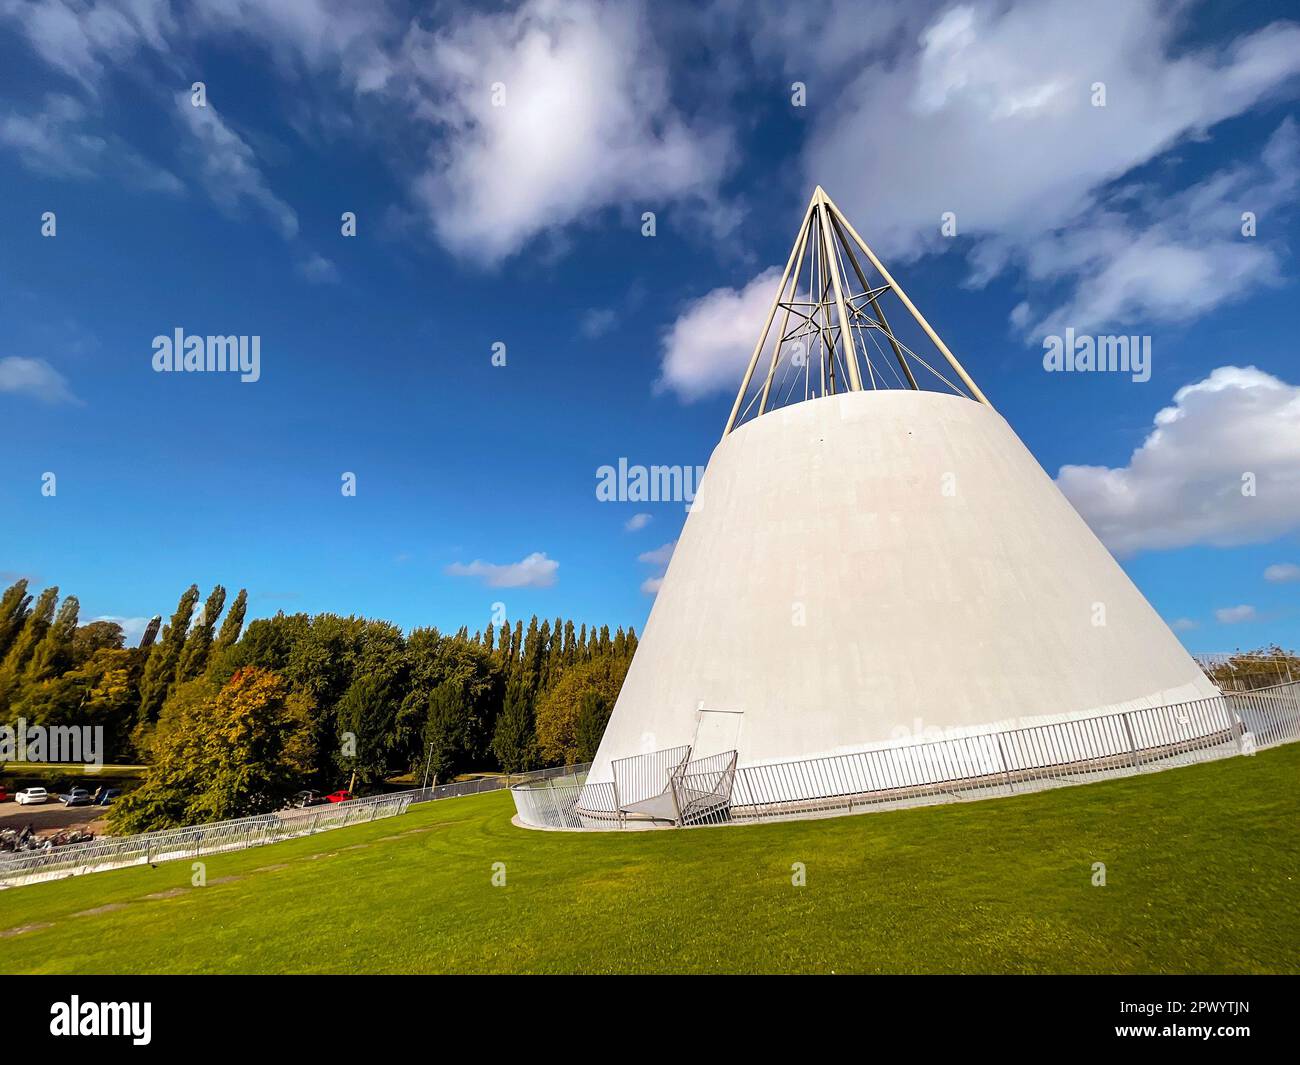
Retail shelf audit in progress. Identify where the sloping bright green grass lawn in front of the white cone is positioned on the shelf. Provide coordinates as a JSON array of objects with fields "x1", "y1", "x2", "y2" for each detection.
[{"x1": 0, "y1": 744, "x2": 1300, "y2": 973}]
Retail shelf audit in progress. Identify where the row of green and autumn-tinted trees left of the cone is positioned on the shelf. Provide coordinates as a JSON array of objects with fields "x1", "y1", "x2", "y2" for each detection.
[{"x1": 0, "y1": 580, "x2": 637, "y2": 831}]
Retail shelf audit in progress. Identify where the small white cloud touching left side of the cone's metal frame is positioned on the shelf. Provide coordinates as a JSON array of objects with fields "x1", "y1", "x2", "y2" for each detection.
[{"x1": 655, "y1": 267, "x2": 781, "y2": 403}]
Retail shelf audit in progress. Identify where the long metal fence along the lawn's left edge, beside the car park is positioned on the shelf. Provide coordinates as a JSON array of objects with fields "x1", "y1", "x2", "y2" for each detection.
[{"x1": 0, "y1": 792, "x2": 411, "y2": 887}]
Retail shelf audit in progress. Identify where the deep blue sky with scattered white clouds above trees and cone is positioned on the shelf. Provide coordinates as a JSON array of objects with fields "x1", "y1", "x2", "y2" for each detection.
[{"x1": 0, "y1": 0, "x2": 1300, "y2": 650}]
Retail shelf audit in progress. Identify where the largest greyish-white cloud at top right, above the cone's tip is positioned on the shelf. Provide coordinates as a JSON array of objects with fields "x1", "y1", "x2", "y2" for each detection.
[{"x1": 789, "y1": 0, "x2": 1300, "y2": 265}]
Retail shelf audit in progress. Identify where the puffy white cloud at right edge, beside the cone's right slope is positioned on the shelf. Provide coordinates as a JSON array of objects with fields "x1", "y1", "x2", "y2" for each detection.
[{"x1": 1057, "y1": 367, "x2": 1300, "y2": 554}]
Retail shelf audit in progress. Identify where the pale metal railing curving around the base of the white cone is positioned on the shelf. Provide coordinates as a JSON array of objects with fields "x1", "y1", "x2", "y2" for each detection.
[{"x1": 514, "y1": 681, "x2": 1300, "y2": 828}]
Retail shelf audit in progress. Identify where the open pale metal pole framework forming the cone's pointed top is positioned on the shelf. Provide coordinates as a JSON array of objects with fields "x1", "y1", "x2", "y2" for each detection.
[{"x1": 723, "y1": 185, "x2": 988, "y2": 437}]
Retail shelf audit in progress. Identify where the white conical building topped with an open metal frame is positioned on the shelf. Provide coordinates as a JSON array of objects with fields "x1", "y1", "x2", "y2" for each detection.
[{"x1": 579, "y1": 189, "x2": 1222, "y2": 819}]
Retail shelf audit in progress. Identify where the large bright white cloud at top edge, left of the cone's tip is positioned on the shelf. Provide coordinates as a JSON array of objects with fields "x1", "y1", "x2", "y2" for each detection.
[{"x1": 400, "y1": 0, "x2": 729, "y2": 264}]
